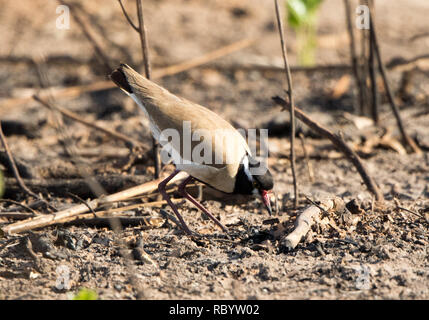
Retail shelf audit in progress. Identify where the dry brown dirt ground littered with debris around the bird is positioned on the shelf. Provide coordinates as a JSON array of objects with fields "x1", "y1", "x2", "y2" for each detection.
[{"x1": 0, "y1": 0, "x2": 429, "y2": 299}]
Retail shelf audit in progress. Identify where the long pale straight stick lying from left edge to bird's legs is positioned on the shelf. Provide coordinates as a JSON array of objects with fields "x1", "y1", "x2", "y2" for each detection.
[{"x1": 2, "y1": 174, "x2": 186, "y2": 235}]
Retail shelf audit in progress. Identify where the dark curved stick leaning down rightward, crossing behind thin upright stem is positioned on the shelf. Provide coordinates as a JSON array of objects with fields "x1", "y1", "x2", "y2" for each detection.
[{"x1": 273, "y1": 97, "x2": 384, "y2": 202}]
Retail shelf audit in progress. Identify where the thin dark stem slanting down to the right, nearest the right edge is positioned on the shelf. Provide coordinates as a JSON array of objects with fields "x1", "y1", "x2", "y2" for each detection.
[{"x1": 370, "y1": 13, "x2": 422, "y2": 154}]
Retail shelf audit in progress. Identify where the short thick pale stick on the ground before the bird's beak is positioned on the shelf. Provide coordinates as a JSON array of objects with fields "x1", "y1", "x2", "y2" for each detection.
[{"x1": 282, "y1": 198, "x2": 344, "y2": 250}]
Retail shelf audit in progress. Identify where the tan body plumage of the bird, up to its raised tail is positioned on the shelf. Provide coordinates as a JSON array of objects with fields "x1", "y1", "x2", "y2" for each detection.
[{"x1": 111, "y1": 65, "x2": 250, "y2": 193}]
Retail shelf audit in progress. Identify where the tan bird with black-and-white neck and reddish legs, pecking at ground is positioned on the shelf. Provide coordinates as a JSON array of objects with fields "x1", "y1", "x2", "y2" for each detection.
[{"x1": 110, "y1": 63, "x2": 274, "y2": 235}]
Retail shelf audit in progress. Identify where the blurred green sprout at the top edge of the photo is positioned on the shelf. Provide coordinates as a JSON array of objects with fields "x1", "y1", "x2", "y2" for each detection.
[{"x1": 286, "y1": 0, "x2": 322, "y2": 66}]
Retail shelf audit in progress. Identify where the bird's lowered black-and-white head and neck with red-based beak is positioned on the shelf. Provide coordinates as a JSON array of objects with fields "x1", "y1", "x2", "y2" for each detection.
[{"x1": 234, "y1": 155, "x2": 274, "y2": 214}]
